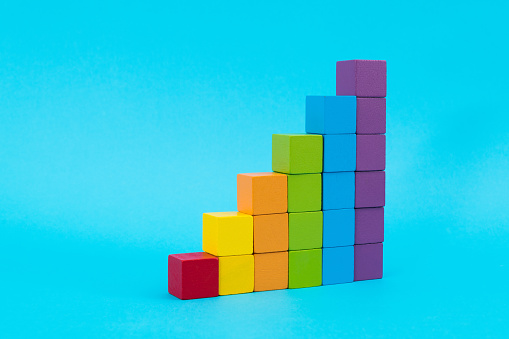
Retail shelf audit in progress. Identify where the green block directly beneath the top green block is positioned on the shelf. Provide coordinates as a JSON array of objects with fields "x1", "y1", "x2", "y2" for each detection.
[{"x1": 288, "y1": 174, "x2": 322, "y2": 212}]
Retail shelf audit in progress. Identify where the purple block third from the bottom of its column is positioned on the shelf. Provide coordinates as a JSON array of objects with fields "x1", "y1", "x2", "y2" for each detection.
[{"x1": 355, "y1": 171, "x2": 385, "y2": 208}]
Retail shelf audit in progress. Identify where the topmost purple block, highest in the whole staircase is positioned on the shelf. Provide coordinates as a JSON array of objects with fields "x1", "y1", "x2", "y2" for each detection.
[{"x1": 336, "y1": 60, "x2": 387, "y2": 98}]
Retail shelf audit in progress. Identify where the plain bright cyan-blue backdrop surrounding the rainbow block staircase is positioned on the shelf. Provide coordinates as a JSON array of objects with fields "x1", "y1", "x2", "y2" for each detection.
[{"x1": 0, "y1": 0, "x2": 509, "y2": 338}]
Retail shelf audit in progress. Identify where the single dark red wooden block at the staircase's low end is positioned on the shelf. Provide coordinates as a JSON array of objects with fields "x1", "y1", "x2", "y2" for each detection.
[{"x1": 168, "y1": 252, "x2": 219, "y2": 299}]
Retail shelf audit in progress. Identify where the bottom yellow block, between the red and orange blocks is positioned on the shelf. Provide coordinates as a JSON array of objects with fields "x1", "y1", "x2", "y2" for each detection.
[{"x1": 219, "y1": 254, "x2": 254, "y2": 295}]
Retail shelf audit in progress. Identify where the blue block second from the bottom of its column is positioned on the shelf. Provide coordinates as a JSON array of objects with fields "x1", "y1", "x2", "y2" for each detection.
[{"x1": 323, "y1": 208, "x2": 355, "y2": 247}]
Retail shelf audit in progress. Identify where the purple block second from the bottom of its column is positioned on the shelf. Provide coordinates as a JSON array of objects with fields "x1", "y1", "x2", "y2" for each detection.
[{"x1": 355, "y1": 207, "x2": 384, "y2": 245}]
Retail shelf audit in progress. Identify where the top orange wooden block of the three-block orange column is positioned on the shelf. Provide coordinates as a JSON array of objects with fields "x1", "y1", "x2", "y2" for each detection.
[{"x1": 237, "y1": 172, "x2": 288, "y2": 215}]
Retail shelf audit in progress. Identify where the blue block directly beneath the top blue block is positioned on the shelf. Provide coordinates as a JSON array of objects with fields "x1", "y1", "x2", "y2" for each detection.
[{"x1": 323, "y1": 134, "x2": 357, "y2": 172}]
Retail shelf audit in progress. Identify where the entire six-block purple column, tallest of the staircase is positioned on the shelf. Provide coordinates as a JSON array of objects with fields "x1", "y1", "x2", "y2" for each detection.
[{"x1": 336, "y1": 60, "x2": 387, "y2": 280}]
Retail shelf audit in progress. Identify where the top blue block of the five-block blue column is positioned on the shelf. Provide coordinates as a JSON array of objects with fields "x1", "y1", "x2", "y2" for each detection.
[{"x1": 306, "y1": 96, "x2": 357, "y2": 134}]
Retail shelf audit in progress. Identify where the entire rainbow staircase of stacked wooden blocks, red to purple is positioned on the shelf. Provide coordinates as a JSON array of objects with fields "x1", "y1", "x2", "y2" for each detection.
[{"x1": 168, "y1": 60, "x2": 386, "y2": 299}]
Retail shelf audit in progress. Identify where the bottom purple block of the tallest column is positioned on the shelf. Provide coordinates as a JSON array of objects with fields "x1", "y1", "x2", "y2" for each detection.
[{"x1": 354, "y1": 243, "x2": 383, "y2": 281}]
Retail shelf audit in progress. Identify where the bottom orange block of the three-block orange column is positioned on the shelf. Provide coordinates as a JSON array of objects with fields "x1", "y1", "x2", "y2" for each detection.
[{"x1": 254, "y1": 251, "x2": 288, "y2": 292}]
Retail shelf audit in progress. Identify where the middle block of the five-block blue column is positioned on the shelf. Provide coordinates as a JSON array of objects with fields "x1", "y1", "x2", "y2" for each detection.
[{"x1": 322, "y1": 172, "x2": 355, "y2": 210}]
